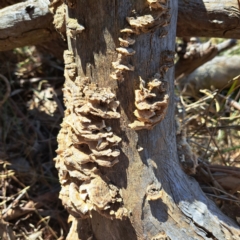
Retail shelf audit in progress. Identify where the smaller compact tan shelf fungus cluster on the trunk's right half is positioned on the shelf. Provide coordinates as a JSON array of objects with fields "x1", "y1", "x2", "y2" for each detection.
[{"x1": 129, "y1": 74, "x2": 169, "y2": 130}]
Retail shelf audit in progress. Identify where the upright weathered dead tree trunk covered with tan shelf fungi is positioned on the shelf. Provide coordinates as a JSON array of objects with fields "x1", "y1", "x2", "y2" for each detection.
[{"x1": 55, "y1": 0, "x2": 240, "y2": 240}]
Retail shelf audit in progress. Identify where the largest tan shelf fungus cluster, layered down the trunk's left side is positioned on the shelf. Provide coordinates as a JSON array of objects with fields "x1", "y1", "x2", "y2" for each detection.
[{"x1": 55, "y1": 74, "x2": 128, "y2": 219}]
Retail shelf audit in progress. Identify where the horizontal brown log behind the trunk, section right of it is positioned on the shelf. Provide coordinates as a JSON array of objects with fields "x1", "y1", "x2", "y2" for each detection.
[{"x1": 177, "y1": 0, "x2": 240, "y2": 38}]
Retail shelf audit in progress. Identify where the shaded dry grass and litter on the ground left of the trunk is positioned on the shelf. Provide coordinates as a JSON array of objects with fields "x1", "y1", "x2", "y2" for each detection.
[{"x1": 0, "y1": 47, "x2": 68, "y2": 240}]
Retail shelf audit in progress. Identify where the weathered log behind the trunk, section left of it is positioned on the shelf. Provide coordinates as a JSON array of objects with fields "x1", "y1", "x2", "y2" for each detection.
[{"x1": 0, "y1": 0, "x2": 62, "y2": 51}]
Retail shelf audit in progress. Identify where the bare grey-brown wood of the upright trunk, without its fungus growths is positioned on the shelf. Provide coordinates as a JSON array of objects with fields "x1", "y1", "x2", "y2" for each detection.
[{"x1": 59, "y1": 0, "x2": 240, "y2": 240}]
